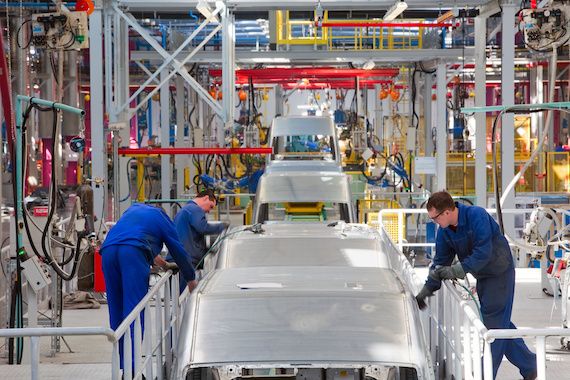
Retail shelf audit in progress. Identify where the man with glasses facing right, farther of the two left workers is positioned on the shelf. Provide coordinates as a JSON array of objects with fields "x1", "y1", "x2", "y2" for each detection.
[{"x1": 174, "y1": 189, "x2": 229, "y2": 268}]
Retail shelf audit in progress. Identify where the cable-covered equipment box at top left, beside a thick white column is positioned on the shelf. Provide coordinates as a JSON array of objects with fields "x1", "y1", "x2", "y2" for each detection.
[{"x1": 32, "y1": 12, "x2": 89, "y2": 50}]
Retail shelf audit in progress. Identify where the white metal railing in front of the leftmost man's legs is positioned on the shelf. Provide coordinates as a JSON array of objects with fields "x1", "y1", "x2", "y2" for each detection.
[{"x1": 0, "y1": 271, "x2": 180, "y2": 380}]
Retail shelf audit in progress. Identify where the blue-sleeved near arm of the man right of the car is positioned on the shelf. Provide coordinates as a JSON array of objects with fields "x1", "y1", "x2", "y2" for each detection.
[{"x1": 461, "y1": 207, "x2": 493, "y2": 273}]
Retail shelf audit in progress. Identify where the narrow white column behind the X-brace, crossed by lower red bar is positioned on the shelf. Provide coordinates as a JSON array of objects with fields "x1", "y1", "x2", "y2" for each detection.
[{"x1": 160, "y1": 69, "x2": 172, "y2": 214}]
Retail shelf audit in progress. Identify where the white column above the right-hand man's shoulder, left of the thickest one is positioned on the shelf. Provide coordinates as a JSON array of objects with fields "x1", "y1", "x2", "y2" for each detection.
[{"x1": 475, "y1": 16, "x2": 487, "y2": 207}]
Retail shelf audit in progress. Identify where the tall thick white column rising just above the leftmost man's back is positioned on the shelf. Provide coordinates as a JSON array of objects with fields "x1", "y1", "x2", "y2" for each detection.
[{"x1": 89, "y1": 7, "x2": 109, "y2": 231}]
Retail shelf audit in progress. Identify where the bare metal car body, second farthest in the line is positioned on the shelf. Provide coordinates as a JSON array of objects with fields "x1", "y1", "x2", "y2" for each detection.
[{"x1": 253, "y1": 171, "x2": 356, "y2": 223}]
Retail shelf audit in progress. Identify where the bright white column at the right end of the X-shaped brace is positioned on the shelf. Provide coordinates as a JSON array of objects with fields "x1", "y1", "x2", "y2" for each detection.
[{"x1": 220, "y1": 4, "x2": 236, "y2": 146}]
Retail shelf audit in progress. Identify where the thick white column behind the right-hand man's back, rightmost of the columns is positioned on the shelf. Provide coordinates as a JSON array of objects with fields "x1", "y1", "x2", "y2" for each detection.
[{"x1": 501, "y1": 4, "x2": 518, "y2": 236}]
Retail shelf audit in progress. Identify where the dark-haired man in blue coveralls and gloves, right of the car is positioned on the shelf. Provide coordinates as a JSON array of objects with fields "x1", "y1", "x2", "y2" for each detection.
[{"x1": 416, "y1": 191, "x2": 537, "y2": 380}]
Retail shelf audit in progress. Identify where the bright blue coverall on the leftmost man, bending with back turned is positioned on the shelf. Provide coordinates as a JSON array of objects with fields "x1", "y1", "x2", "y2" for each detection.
[{"x1": 100, "y1": 203, "x2": 195, "y2": 368}]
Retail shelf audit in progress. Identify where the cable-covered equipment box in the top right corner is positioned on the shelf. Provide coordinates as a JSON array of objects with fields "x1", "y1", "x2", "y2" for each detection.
[{"x1": 520, "y1": 5, "x2": 570, "y2": 51}]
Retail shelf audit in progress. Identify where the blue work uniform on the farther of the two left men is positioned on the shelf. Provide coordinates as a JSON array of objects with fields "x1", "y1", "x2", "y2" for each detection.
[{"x1": 174, "y1": 201, "x2": 225, "y2": 267}]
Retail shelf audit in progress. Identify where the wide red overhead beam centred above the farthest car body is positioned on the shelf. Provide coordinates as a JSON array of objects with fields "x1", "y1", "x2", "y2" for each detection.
[{"x1": 206, "y1": 67, "x2": 400, "y2": 79}]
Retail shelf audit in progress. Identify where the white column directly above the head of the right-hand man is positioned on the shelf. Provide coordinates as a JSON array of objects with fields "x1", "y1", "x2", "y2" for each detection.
[{"x1": 432, "y1": 62, "x2": 447, "y2": 191}]
